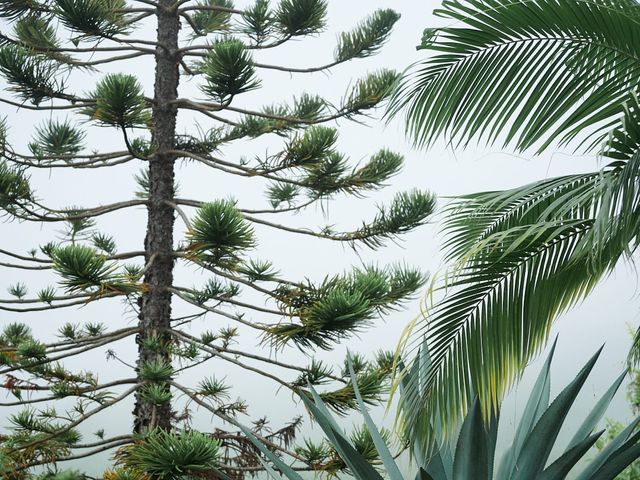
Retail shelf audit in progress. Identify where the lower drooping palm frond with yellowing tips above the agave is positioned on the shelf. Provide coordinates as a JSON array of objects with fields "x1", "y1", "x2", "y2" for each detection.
[{"x1": 403, "y1": 126, "x2": 640, "y2": 436}]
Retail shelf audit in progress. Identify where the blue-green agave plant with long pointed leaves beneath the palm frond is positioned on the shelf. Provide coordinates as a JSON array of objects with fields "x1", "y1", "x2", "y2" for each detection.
[{"x1": 245, "y1": 344, "x2": 640, "y2": 480}]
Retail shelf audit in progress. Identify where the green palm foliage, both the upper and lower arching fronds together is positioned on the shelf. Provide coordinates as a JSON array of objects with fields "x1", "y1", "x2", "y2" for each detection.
[{"x1": 390, "y1": 0, "x2": 640, "y2": 432}]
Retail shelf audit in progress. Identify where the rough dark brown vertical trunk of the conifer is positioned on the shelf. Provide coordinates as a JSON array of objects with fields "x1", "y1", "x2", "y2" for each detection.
[{"x1": 133, "y1": 0, "x2": 180, "y2": 433}]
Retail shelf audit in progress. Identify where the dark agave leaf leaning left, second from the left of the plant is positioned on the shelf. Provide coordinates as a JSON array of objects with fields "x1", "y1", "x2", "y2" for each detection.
[{"x1": 302, "y1": 387, "x2": 383, "y2": 480}]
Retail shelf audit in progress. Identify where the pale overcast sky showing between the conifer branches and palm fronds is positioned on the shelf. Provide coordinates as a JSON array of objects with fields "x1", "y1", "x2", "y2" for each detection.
[{"x1": 0, "y1": 0, "x2": 638, "y2": 473}]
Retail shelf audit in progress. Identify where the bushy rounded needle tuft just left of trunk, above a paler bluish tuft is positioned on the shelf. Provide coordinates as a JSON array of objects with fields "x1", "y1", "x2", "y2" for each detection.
[{"x1": 82, "y1": 73, "x2": 151, "y2": 128}]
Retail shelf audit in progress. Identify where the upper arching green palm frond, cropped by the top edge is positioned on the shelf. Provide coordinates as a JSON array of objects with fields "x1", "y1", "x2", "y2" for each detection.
[{"x1": 390, "y1": 0, "x2": 640, "y2": 151}]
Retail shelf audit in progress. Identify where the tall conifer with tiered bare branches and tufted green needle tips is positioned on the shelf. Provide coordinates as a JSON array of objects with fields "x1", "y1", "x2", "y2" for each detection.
[{"x1": 0, "y1": 0, "x2": 434, "y2": 478}]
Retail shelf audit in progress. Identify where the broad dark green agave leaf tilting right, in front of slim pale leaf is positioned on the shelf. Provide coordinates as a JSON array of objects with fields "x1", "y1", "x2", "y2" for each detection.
[{"x1": 511, "y1": 348, "x2": 602, "y2": 480}]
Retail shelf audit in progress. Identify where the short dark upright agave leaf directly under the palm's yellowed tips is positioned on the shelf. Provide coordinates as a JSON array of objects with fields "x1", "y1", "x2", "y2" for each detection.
[{"x1": 453, "y1": 399, "x2": 498, "y2": 480}]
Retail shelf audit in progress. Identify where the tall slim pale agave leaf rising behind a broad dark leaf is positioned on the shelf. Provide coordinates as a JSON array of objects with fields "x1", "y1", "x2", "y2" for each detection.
[{"x1": 496, "y1": 338, "x2": 558, "y2": 480}]
